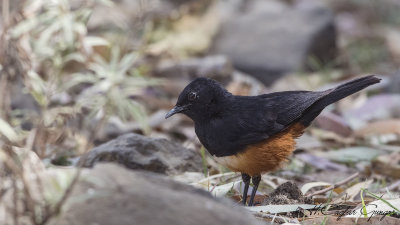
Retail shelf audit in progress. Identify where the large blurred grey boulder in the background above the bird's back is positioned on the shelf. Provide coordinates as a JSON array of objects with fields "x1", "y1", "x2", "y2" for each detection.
[{"x1": 212, "y1": 0, "x2": 336, "y2": 85}]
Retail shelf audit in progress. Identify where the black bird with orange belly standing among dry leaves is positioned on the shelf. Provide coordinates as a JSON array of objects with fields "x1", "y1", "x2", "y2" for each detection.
[{"x1": 165, "y1": 75, "x2": 381, "y2": 206}]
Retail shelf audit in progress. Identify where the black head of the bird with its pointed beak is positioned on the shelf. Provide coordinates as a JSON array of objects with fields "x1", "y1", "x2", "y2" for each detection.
[{"x1": 165, "y1": 78, "x2": 231, "y2": 122}]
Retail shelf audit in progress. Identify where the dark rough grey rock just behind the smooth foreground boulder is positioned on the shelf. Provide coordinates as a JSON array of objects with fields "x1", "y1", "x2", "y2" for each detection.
[{"x1": 79, "y1": 133, "x2": 202, "y2": 174}]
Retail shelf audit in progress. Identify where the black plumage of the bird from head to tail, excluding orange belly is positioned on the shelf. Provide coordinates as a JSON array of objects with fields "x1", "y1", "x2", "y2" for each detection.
[{"x1": 166, "y1": 76, "x2": 380, "y2": 157}]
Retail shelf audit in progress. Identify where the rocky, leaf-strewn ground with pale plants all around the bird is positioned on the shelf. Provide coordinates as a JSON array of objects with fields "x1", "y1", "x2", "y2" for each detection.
[{"x1": 0, "y1": 0, "x2": 400, "y2": 225}]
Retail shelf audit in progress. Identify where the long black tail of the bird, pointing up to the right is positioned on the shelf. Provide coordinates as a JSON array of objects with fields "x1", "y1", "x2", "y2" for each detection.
[{"x1": 300, "y1": 75, "x2": 381, "y2": 126}]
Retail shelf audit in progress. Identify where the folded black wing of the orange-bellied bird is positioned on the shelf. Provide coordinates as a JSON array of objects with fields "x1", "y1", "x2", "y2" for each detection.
[{"x1": 222, "y1": 91, "x2": 327, "y2": 155}]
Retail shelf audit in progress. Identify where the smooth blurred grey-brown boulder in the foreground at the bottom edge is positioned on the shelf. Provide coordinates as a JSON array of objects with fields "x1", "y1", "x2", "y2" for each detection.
[{"x1": 50, "y1": 164, "x2": 261, "y2": 225}]
